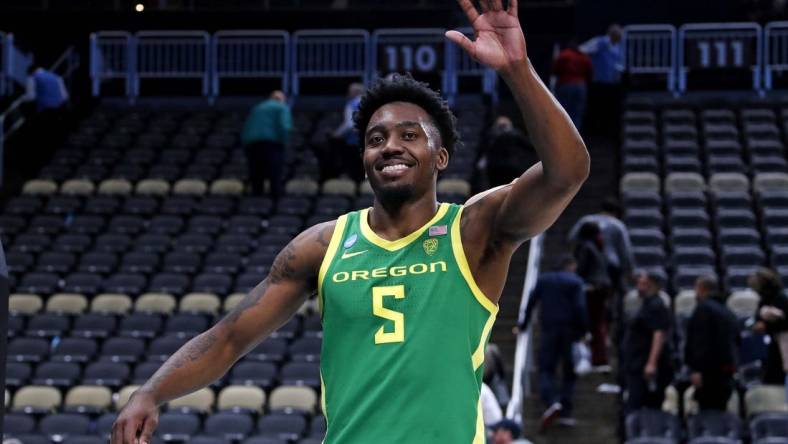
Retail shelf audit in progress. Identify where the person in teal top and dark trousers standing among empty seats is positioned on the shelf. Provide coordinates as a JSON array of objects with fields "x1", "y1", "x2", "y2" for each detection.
[{"x1": 241, "y1": 91, "x2": 293, "y2": 199}]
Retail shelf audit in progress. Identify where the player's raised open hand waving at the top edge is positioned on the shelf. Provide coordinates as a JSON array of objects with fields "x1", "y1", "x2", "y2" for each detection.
[{"x1": 446, "y1": 0, "x2": 526, "y2": 71}]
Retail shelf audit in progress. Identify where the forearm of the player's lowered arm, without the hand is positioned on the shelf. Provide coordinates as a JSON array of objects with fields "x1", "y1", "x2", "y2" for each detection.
[{"x1": 139, "y1": 325, "x2": 238, "y2": 405}]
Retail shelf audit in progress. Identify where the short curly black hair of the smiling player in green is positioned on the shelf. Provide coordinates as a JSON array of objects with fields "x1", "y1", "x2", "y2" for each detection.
[{"x1": 353, "y1": 73, "x2": 460, "y2": 156}]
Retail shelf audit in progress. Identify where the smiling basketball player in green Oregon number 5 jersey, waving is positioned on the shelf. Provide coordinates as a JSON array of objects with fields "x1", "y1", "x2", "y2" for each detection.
[{"x1": 112, "y1": 0, "x2": 589, "y2": 444}]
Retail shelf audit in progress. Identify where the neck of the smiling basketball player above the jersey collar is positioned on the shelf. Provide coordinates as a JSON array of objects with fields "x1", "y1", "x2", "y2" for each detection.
[{"x1": 367, "y1": 195, "x2": 438, "y2": 240}]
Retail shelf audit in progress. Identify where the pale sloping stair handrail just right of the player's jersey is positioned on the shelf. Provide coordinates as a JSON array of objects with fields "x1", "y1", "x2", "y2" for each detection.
[{"x1": 506, "y1": 233, "x2": 544, "y2": 423}]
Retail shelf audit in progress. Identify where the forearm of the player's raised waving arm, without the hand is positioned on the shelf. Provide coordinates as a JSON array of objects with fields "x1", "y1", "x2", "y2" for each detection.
[{"x1": 500, "y1": 59, "x2": 589, "y2": 186}]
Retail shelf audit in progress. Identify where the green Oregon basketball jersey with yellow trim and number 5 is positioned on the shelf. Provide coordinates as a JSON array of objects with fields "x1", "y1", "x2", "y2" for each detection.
[{"x1": 318, "y1": 204, "x2": 498, "y2": 444}]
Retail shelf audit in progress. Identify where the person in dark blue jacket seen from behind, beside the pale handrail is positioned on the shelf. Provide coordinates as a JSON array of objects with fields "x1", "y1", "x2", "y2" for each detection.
[{"x1": 520, "y1": 256, "x2": 588, "y2": 429}]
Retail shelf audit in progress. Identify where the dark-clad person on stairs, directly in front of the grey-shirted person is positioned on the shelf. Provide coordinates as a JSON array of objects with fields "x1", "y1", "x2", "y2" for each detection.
[{"x1": 575, "y1": 222, "x2": 611, "y2": 367}]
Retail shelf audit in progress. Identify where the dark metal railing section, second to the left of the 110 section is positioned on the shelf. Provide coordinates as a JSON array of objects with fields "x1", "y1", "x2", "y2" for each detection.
[{"x1": 211, "y1": 31, "x2": 290, "y2": 96}]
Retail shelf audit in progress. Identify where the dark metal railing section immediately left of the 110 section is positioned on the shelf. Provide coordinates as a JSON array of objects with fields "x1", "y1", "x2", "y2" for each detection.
[{"x1": 291, "y1": 29, "x2": 370, "y2": 95}]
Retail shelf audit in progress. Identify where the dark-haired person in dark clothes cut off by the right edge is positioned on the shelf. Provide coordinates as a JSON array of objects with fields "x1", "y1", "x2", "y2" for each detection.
[{"x1": 747, "y1": 268, "x2": 788, "y2": 400}]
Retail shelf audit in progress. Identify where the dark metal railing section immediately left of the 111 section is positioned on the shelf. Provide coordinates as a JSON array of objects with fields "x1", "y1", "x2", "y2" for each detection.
[{"x1": 622, "y1": 25, "x2": 676, "y2": 91}]
